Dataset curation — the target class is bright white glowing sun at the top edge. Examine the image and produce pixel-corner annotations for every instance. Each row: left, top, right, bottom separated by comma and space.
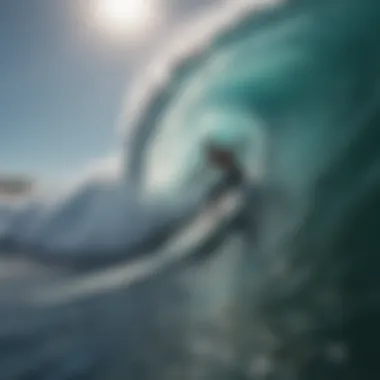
94, 0, 158, 37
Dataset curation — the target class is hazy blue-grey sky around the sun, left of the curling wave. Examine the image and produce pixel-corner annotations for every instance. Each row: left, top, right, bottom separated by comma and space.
0, 0, 218, 187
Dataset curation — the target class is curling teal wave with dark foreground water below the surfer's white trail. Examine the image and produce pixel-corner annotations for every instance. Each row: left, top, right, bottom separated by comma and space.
0, 0, 380, 380
